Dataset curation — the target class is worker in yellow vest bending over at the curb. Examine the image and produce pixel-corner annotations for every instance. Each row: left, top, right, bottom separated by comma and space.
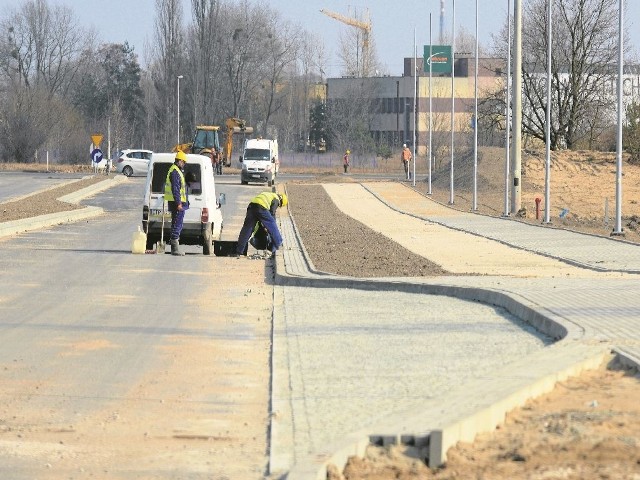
236, 192, 289, 255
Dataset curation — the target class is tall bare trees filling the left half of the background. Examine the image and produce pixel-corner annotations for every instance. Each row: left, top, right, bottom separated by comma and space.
0, 0, 325, 162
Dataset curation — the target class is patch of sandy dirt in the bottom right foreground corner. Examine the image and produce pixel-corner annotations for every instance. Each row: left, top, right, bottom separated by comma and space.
328, 367, 640, 480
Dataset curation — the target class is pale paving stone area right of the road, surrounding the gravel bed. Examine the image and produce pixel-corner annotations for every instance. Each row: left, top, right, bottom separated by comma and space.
272, 183, 640, 478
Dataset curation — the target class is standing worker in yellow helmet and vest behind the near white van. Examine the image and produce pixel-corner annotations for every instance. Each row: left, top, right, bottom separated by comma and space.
164, 150, 189, 255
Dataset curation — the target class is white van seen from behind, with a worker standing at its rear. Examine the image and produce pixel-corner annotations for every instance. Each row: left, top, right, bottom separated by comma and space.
142, 153, 225, 255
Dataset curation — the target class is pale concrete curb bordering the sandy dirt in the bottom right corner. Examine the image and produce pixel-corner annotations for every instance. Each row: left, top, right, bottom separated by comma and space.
286, 344, 613, 480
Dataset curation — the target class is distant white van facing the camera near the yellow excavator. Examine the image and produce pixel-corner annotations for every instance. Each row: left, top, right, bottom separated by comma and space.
240, 138, 280, 187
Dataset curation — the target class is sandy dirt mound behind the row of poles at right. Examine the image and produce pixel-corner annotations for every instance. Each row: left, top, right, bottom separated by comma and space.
424, 148, 640, 243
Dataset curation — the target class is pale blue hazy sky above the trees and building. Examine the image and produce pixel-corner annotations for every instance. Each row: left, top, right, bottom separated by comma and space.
0, 0, 640, 76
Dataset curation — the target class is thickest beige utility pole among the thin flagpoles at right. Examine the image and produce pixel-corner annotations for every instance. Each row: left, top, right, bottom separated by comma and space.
511, 0, 522, 215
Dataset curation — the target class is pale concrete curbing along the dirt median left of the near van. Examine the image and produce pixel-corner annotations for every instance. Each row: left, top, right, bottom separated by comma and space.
0, 176, 126, 238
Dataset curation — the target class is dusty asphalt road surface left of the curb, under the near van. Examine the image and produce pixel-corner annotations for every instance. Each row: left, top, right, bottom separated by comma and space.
0, 174, 272, 480
